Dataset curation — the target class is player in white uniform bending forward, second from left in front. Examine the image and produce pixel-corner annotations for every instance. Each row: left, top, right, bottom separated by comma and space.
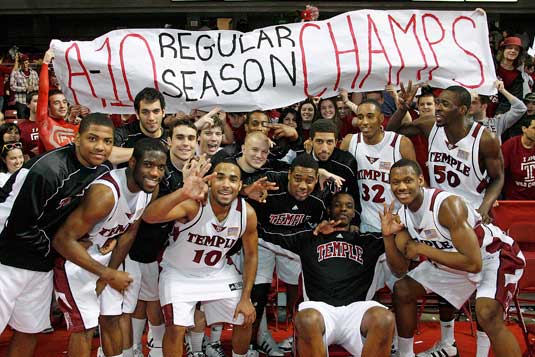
53, 139, 167, 356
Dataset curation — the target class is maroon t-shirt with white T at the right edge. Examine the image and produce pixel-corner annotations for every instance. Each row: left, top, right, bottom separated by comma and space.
502, 135, 535, 200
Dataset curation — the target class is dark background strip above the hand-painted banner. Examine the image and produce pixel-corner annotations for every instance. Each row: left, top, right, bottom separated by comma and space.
0, 0, 535, 52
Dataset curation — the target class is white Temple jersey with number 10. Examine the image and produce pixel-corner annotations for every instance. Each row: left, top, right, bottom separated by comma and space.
162, 198, 247, 278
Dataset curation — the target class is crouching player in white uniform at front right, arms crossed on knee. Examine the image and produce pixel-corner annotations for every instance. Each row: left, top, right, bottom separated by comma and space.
382, 159, 525, 357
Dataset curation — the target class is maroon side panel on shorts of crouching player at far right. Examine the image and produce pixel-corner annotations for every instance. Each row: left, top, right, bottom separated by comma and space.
486, 237, 526, 312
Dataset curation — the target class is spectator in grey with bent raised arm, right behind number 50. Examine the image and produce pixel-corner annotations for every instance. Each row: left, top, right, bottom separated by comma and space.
468, 80, 527, 143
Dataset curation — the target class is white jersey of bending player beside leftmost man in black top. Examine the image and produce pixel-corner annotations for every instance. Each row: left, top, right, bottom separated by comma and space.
89, 168, 152, 246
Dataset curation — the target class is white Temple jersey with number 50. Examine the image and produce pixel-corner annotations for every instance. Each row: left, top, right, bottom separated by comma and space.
427, 123, 488, 209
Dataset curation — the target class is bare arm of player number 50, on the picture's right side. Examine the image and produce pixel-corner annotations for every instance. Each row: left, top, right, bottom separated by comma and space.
478, 129, 505, 223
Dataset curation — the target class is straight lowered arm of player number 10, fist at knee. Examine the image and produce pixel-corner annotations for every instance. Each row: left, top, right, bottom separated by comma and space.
234, 204, 258, 326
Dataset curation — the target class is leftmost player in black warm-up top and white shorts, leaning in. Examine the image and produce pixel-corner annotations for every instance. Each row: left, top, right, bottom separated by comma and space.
0, 113, 115, 356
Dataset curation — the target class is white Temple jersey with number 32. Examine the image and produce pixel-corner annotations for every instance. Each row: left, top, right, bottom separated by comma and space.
349, 131, 402, 232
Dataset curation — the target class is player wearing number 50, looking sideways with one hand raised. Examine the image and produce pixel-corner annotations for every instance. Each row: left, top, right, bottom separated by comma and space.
387, 82, 504, 357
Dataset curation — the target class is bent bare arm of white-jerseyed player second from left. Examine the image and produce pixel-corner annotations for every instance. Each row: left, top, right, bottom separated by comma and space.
52, 184, 132, 290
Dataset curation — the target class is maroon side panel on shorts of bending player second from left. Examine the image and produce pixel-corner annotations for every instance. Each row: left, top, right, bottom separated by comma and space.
54, 257, 88, 332
